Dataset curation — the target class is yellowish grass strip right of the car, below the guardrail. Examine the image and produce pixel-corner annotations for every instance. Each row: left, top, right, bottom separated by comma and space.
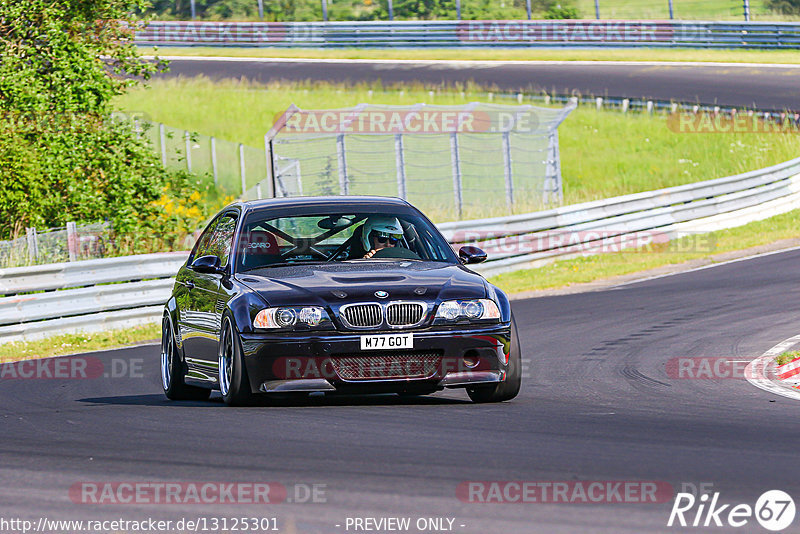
489, 210, 800, 294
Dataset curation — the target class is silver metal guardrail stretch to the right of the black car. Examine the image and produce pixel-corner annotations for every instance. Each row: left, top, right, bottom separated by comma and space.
446, 158, 800, 276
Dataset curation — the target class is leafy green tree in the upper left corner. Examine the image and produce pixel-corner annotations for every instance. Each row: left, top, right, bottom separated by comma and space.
0, 0, 169, 238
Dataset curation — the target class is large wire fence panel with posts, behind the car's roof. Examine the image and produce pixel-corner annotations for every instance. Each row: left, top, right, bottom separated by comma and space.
268, 102, 576, 220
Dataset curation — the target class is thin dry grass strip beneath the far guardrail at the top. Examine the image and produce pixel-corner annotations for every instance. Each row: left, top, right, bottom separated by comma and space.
140, 47, 797, 64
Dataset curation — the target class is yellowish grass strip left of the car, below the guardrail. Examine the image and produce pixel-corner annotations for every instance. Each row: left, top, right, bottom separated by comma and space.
0, 323, 161, 363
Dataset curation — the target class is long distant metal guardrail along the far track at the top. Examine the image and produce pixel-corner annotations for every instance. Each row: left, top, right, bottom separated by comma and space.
134, 20, 800, 48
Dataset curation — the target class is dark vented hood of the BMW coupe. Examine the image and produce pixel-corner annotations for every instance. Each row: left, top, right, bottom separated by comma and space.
237, 260, 486, 308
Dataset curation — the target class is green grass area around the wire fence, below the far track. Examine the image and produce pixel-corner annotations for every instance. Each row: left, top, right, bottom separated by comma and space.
116, 78, 800, 211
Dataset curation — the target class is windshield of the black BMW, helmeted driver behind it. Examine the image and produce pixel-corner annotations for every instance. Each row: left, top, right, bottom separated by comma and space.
237, 212, 457, 271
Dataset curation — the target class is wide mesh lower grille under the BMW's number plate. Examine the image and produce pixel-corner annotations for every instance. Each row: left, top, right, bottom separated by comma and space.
331, 351, 442, 380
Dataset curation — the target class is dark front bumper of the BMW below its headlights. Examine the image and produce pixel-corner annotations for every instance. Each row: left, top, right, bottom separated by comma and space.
241, 323, 511, 393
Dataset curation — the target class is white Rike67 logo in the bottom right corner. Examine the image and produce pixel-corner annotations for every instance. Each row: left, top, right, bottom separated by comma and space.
667, 490, 795, 532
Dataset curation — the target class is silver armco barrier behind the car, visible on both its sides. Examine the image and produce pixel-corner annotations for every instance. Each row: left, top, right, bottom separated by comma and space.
0, 158, 800, 341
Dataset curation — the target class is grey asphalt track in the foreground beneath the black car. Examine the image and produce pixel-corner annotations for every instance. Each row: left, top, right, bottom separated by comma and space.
0, 251, 800, 534
